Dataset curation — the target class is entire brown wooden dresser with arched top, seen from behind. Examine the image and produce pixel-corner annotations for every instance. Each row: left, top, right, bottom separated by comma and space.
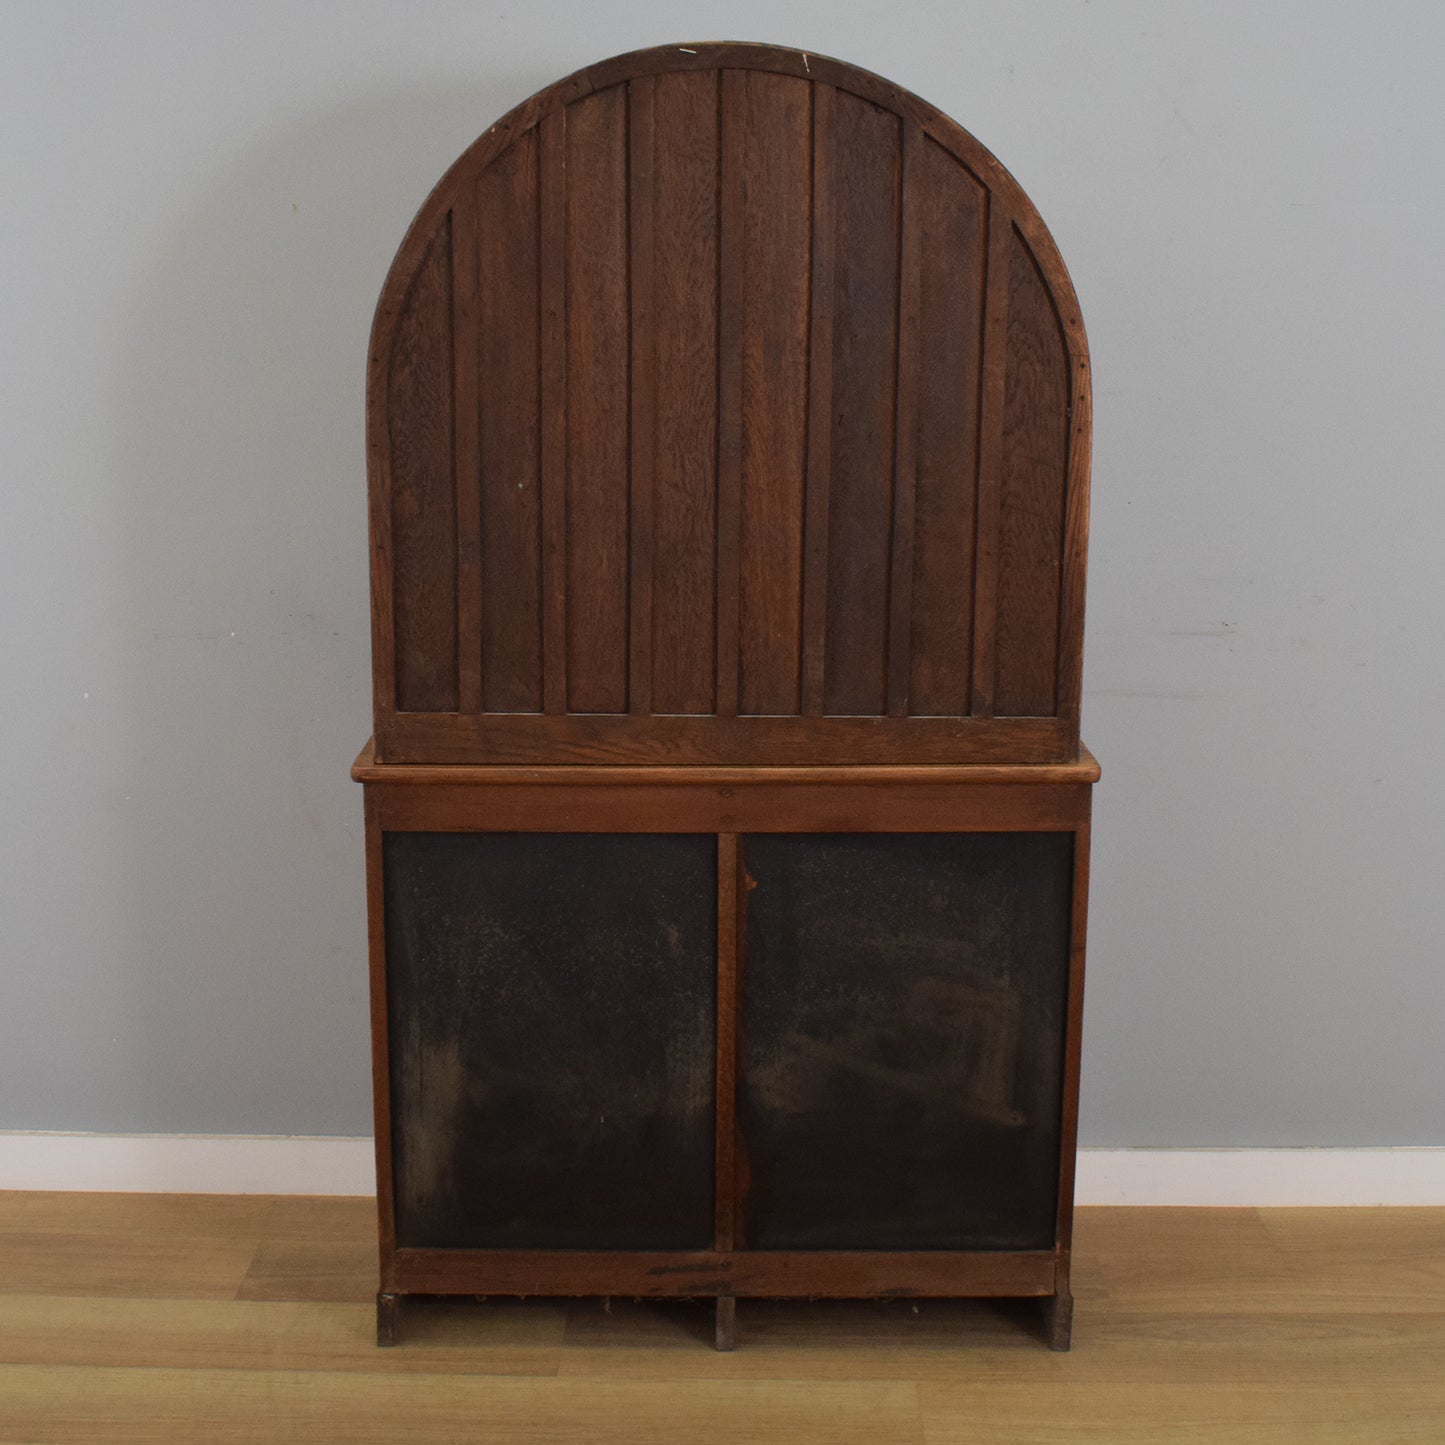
354, 45, 1098, 1348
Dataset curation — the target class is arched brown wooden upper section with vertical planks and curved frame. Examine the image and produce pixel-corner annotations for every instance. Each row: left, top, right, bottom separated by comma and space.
367, 43, 1090, 764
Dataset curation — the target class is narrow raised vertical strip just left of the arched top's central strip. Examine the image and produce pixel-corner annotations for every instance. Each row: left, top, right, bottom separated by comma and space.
627, 75, 657, 714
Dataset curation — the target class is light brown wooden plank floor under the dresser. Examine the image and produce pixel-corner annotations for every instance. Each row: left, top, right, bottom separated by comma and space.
0, 1194, 1445, 1445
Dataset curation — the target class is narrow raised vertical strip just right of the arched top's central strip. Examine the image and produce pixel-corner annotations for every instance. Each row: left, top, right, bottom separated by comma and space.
802, 81, 837, 717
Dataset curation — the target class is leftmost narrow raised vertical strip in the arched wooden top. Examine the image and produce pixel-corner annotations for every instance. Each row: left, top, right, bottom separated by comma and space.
451, 182, 481, 712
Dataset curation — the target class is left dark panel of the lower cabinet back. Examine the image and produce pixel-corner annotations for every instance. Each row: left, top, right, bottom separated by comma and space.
383, 832, 717, 1248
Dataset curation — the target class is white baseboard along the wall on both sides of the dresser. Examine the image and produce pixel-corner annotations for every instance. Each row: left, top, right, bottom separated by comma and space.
0, 1133, 1445, 1207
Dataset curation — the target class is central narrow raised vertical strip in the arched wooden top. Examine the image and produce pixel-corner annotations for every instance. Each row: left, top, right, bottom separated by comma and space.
717, 69, 747, 717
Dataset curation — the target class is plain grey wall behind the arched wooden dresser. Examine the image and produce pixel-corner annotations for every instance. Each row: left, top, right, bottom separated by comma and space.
0, 0, 1445, 1144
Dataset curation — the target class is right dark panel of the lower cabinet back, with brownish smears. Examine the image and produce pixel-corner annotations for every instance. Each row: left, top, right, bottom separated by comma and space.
738, 832, 1074, 1250
